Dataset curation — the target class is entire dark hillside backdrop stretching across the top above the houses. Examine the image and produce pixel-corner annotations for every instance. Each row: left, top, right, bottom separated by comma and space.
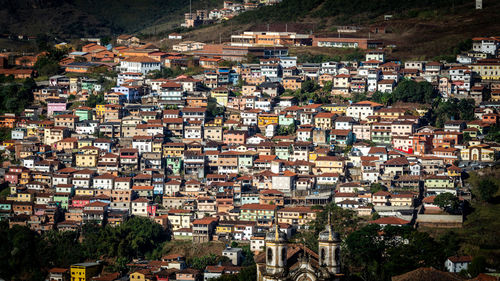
0, 0, 500, 59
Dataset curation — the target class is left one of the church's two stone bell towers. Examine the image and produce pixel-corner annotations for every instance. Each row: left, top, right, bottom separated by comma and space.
264, 212, 287, 281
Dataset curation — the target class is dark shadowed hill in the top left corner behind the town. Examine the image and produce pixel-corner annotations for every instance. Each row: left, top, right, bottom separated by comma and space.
0, 0, 223, 38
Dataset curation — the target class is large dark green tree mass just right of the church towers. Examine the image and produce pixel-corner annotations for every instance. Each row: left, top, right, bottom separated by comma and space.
343, 224, 446, 280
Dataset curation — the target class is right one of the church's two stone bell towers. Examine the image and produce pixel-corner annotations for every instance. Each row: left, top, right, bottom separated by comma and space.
318, 212, 340, 274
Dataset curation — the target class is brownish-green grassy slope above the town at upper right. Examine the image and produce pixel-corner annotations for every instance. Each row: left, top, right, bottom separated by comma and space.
179, 0, 500, 60
